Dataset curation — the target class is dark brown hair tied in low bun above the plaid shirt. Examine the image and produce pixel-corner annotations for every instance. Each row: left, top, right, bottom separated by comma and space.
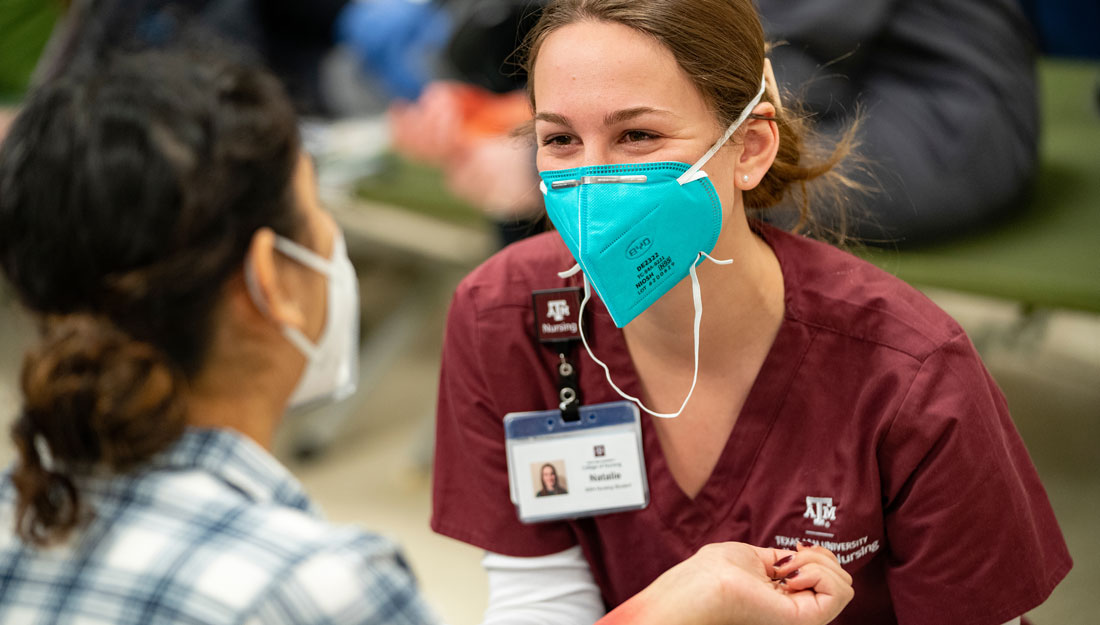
0, 41, 299, 545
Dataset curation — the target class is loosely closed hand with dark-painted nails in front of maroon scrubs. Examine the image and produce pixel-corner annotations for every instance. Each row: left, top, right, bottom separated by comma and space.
600, 542, 855, 625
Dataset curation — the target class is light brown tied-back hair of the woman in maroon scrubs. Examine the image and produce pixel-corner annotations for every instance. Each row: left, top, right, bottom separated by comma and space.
523, 0, 862, 242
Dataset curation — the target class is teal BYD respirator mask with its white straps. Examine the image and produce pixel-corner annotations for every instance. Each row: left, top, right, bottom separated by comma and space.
539, 79, 767, 417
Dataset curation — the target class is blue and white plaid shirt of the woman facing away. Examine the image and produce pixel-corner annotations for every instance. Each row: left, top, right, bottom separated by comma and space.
0, 429, 435, 625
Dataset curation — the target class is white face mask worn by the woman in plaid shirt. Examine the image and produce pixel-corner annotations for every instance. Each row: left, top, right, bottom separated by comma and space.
244, 230, 359, 409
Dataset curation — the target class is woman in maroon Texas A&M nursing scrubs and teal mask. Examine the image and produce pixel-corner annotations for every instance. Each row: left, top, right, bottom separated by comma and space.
432, 0, 1071, 625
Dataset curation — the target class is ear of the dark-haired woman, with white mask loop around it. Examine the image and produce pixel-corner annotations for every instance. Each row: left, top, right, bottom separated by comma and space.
244, 228, 306, 329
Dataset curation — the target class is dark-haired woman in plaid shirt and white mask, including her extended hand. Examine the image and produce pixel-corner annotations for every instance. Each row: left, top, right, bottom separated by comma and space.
0, 33, 851, 625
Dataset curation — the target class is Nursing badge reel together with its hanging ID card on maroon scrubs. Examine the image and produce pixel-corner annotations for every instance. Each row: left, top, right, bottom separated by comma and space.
504, 288, 649, 523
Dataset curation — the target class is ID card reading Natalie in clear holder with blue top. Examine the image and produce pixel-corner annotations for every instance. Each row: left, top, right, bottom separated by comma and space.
504, 402, 649, 523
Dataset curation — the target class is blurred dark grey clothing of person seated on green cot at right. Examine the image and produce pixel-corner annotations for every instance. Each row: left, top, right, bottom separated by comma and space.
758, 0, 1038, 244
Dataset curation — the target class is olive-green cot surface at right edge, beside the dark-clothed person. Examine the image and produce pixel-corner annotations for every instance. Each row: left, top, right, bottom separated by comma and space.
861, 61, 1100, 313
